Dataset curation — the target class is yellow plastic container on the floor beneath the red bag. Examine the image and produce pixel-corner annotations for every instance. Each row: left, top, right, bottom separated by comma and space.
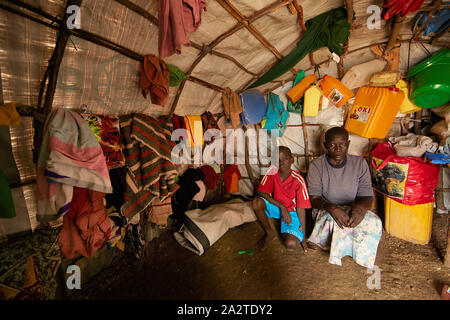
384, 197, 434, 244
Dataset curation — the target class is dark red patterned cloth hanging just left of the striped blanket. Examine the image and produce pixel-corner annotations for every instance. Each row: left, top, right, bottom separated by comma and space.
81, 113, 125, 169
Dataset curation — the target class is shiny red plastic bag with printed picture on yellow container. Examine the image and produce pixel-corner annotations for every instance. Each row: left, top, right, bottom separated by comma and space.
371, 142, 440, 205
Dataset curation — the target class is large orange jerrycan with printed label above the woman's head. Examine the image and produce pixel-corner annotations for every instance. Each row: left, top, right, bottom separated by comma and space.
345, 86, 404, 139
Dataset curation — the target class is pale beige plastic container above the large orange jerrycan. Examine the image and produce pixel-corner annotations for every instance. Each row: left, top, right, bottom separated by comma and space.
341, 59, 386, 89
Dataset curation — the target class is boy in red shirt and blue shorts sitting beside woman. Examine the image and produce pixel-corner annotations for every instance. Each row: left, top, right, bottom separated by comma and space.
253, 146, 311, 252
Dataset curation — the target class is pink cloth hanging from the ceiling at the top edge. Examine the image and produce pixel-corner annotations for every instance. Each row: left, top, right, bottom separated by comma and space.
158, 0, 206, 59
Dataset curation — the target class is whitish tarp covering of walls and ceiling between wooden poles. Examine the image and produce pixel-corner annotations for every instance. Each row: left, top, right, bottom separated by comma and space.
0, 0, 448, 235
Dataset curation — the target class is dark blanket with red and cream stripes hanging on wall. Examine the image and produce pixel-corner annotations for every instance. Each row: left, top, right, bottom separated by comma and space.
120, 114, 178, 219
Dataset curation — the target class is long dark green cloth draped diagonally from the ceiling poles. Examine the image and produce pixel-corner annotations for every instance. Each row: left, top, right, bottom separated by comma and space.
248, 8, 350, 89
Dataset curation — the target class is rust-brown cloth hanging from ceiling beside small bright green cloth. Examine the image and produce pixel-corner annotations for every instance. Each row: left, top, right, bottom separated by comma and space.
141, 54, 170, 106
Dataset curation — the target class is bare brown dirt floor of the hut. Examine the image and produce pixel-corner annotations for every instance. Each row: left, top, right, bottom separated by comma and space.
70, 210, 450, 300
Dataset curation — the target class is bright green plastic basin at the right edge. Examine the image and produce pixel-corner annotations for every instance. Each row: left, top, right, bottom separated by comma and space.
408, 48, 450, 108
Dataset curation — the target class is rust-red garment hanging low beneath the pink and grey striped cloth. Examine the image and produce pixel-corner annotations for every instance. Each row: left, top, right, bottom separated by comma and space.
59, 187, 111, 259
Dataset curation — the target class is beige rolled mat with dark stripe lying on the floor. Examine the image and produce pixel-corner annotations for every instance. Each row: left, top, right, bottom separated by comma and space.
173, 199, 256, 256
